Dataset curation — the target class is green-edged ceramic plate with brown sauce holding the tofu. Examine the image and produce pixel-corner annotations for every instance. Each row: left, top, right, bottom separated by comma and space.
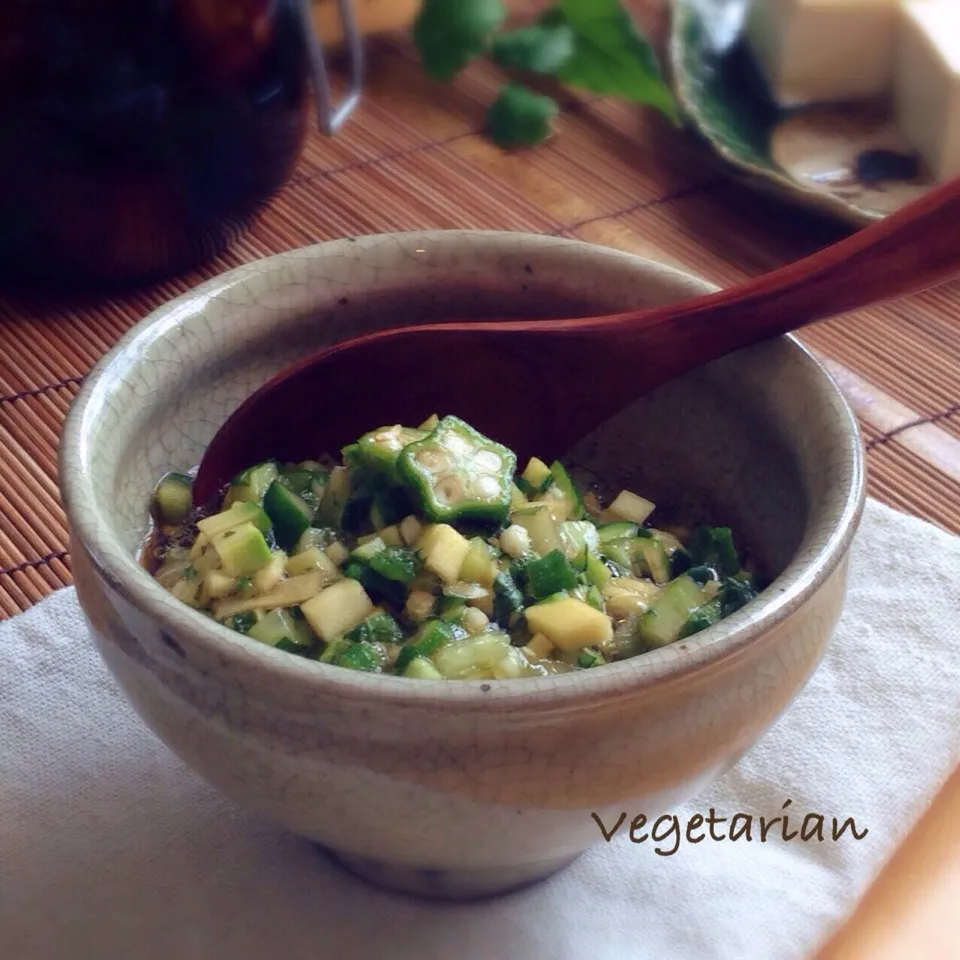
669, 0, 933, 226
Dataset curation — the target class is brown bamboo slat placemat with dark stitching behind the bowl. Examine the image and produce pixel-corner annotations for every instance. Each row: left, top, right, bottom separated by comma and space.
0, 15, 960, 619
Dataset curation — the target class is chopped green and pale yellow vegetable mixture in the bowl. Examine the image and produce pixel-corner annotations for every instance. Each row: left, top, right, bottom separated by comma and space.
148, 416, 759, 680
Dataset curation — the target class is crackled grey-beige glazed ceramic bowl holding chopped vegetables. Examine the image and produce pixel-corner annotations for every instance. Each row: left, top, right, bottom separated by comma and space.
61, 231, 864, 899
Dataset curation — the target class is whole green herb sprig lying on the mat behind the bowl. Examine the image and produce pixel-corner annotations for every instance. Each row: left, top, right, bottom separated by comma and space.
413, 0, 679, 149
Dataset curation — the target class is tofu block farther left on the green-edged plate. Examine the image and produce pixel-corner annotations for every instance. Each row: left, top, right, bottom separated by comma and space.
745, 0, 900, 106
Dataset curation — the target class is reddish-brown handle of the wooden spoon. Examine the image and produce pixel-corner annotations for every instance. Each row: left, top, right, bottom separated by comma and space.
608, 172, 960, 366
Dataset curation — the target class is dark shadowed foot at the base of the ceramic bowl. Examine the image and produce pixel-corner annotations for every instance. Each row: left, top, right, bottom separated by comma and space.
318, 844, 580, 901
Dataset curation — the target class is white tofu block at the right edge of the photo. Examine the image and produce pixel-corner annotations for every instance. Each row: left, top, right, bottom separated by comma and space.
894, 0, 960, 180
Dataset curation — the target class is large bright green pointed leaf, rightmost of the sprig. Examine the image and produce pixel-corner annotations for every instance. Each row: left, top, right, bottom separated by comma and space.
557, 0, 678, 123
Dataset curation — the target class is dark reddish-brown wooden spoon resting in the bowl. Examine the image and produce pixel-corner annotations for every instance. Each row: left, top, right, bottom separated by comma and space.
194, 179, 960, 502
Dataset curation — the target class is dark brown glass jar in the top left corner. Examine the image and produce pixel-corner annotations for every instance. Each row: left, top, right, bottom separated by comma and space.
0, 0, 310, 285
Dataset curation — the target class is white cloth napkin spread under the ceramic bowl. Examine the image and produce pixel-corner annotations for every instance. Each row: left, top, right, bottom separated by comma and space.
0, 501, 960, 960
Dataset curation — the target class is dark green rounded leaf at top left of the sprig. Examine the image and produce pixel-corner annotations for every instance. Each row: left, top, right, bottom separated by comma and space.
413, 0, 506, 81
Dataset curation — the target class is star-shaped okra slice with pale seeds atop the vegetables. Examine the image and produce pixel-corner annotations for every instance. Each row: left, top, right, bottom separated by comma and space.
398, 417, 517, 525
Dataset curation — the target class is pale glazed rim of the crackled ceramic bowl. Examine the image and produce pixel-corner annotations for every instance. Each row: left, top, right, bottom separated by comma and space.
58, 229, 866, 711
